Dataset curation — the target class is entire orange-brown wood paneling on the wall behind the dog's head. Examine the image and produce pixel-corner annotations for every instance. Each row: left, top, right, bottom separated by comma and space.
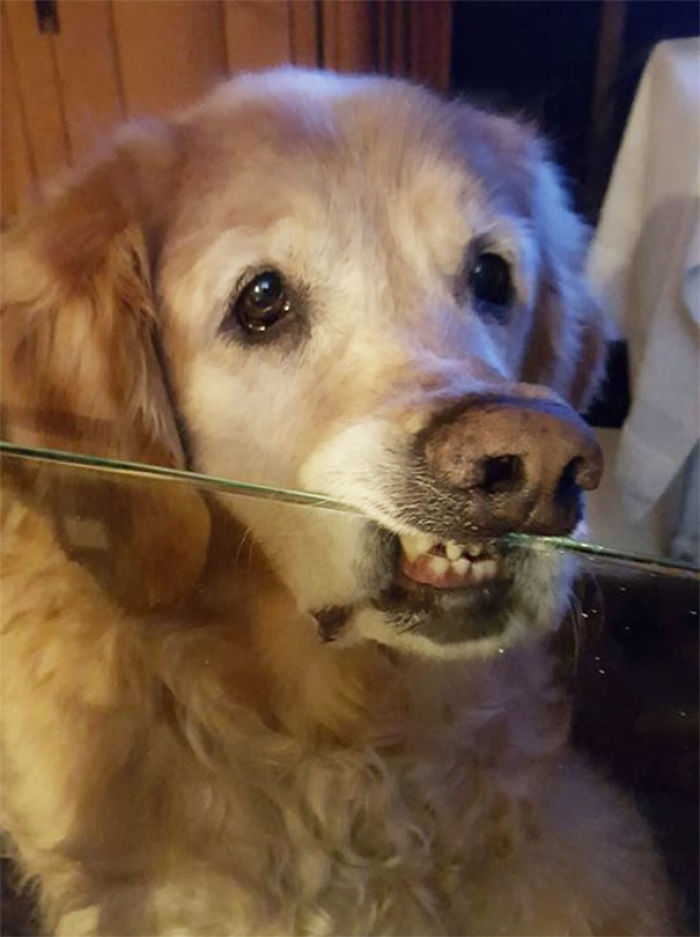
0, 0, 450, 218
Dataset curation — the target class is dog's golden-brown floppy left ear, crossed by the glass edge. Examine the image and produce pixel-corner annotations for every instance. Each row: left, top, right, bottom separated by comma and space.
1, 126, 209, 609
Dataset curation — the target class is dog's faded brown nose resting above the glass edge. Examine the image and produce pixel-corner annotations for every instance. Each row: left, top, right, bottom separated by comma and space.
420, 395, 603, 535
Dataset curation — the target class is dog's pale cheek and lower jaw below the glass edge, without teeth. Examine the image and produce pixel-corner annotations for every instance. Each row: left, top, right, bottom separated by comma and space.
216, 482, 570, 659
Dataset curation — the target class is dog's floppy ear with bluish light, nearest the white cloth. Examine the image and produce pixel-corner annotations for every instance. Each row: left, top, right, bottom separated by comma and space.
522, 152, 609, 412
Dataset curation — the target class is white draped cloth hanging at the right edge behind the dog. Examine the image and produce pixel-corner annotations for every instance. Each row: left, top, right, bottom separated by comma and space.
588, 38, 700, 540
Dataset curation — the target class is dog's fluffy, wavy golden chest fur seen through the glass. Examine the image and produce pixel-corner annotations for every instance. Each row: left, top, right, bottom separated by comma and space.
3, 494, 584, 934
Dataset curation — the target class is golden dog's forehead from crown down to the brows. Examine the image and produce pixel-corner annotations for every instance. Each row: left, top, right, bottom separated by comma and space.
161, 70, 540, 324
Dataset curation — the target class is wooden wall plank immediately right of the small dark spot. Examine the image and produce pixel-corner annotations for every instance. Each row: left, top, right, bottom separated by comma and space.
51, 0, 125, 155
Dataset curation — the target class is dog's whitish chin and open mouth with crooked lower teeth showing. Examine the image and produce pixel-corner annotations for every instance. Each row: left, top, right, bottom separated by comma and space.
334, 530, 571, 658
